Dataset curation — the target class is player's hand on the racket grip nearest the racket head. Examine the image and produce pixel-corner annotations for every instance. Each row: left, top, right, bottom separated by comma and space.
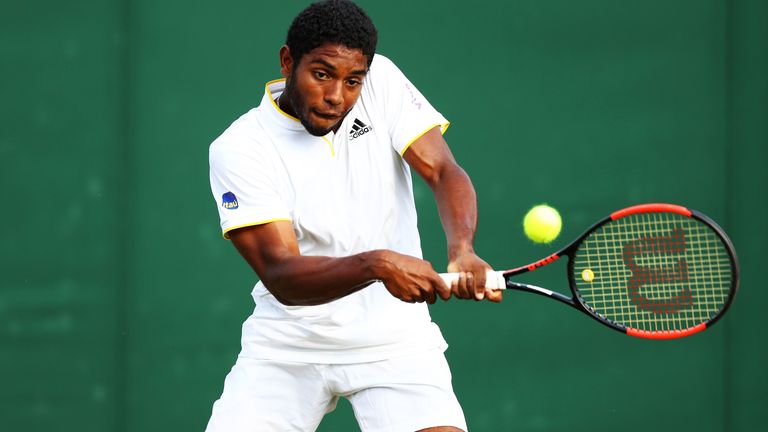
448, 252, 503, 303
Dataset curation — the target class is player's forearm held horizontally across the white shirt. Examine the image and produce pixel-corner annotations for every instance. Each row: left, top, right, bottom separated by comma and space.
262, 251, 388, 306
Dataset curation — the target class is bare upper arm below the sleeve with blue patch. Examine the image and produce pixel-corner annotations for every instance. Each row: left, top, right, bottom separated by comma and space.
229, 221, 300, 280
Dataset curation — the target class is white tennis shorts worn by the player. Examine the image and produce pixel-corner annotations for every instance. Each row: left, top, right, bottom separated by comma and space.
206, 350, 467, 432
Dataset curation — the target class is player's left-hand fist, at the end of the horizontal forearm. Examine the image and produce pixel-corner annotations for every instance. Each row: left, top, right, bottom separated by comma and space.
379, 251, 451, 304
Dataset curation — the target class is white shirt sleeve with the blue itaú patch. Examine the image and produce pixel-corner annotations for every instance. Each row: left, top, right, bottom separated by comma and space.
209, 138, 291, 239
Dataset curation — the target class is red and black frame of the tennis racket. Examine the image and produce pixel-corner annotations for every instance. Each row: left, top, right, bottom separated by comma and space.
502, 204, 739, 339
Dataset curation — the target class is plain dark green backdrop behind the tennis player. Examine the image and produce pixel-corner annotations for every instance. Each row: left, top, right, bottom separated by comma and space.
0, 0, 768, 432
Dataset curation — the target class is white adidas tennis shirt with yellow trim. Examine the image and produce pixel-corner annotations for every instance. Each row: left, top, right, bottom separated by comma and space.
210, 55, 448, 364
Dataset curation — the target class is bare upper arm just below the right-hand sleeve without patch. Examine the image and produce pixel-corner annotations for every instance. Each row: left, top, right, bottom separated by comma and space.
403, 126, 456, 187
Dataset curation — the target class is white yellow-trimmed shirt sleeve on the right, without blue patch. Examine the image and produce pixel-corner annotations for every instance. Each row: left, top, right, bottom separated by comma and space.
369, 54, 450, 156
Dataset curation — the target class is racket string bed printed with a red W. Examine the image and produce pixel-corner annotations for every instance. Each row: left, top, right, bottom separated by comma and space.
573, 213, 733, 331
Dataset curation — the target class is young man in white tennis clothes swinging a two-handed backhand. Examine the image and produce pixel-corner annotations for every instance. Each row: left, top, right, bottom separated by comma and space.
207, 0, 501, 432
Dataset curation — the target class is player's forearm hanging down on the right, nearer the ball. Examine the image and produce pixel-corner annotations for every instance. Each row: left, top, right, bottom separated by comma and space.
430, 164, 477, 260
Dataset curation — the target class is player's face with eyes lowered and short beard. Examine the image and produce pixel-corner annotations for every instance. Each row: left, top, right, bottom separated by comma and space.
280, 44, 368, 136
